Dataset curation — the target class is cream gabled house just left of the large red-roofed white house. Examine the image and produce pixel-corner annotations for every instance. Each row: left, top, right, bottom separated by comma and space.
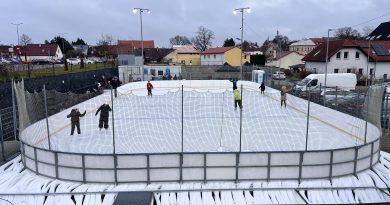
265, 51, 304, 69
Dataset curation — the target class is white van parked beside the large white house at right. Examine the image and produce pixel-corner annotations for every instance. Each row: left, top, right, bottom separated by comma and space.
294, 73, 357, 91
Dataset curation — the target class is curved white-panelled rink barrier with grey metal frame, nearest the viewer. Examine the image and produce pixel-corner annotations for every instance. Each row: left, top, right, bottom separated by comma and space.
21, 139, 380, 184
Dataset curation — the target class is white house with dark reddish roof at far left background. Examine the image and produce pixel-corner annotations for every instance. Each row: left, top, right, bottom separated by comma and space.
20, 44, 63, 62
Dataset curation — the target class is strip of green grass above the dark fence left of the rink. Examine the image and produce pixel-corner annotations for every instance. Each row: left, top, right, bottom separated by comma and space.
0, 63, 115, 81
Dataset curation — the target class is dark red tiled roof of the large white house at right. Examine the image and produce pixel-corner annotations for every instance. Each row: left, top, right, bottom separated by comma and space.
302, 39, 390, 62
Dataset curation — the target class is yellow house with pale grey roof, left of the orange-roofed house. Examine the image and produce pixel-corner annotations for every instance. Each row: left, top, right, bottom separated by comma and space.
166, 45, 200, 65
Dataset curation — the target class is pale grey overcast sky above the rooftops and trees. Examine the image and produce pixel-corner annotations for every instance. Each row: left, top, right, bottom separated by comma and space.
0, 0, 390, 47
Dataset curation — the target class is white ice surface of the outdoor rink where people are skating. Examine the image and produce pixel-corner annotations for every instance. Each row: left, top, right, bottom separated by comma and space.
21, 80, 380, 154
